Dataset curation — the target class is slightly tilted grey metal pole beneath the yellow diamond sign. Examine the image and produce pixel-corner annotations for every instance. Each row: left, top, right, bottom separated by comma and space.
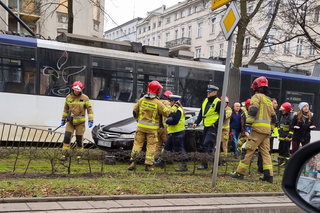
212, 33, 233, 188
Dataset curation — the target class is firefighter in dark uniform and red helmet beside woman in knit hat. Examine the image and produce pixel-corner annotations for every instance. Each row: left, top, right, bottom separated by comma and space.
278, 102, 293, 167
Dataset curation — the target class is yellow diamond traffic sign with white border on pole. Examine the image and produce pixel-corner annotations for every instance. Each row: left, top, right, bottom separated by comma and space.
220, 2, 240, 40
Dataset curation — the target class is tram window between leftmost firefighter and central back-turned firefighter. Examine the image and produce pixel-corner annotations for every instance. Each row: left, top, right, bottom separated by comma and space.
91, 58, 134, 102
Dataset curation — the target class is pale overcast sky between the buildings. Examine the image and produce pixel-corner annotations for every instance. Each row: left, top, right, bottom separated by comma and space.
104, 0, 184, 31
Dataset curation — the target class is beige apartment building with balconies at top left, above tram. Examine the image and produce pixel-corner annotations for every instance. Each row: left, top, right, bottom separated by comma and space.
0, 0, 105, 39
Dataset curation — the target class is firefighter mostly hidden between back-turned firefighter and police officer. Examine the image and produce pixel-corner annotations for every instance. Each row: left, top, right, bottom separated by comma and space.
156, 90, 173, 153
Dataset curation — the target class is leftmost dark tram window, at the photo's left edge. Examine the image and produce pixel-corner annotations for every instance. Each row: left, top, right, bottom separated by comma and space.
0, 58, 36, 94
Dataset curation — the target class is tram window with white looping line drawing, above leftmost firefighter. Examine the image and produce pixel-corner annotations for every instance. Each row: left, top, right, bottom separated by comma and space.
39, 49, 88, 97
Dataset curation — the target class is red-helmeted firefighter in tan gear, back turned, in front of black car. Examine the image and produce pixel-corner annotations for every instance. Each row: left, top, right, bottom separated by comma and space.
128, 81, 180, 171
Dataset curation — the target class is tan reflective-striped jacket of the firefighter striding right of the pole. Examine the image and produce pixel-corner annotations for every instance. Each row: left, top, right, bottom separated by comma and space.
247, 93, 275, 135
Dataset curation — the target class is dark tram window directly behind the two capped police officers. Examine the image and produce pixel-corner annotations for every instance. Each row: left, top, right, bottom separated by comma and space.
178, 67, 214, 107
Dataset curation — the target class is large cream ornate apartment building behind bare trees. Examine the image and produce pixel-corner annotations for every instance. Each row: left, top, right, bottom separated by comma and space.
137, 0, 320, 74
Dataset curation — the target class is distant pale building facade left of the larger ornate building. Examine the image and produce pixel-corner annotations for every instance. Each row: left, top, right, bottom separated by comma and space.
104, 17, 142, 41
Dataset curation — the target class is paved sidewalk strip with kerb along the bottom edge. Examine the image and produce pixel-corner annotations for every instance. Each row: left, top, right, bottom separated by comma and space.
0, 193, 305, 213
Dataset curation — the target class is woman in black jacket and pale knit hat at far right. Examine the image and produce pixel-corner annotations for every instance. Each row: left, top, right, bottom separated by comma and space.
291, 102, 316, 155
